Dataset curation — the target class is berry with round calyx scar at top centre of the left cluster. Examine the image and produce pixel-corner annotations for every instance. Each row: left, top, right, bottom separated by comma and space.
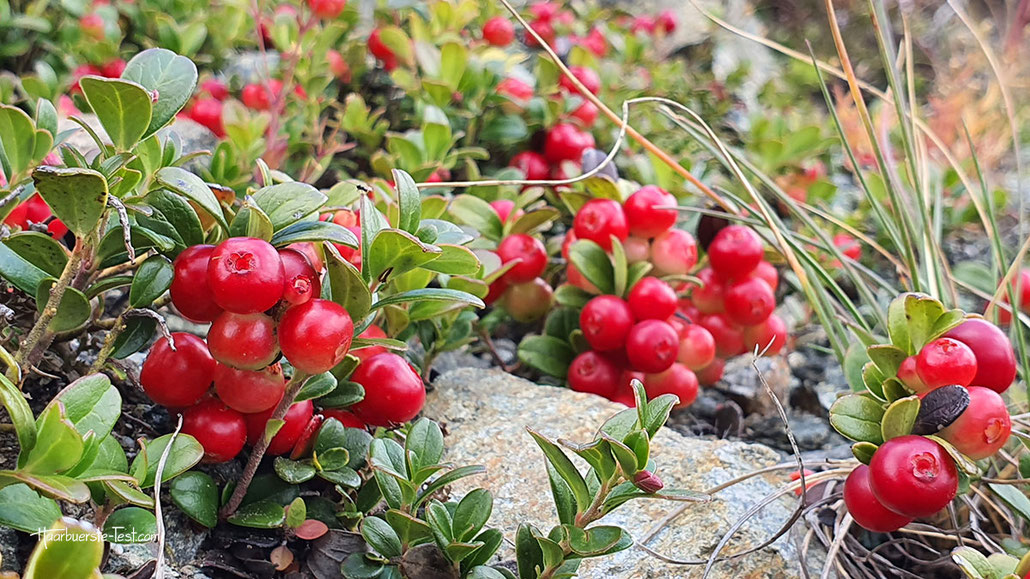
207, 237, 285, 313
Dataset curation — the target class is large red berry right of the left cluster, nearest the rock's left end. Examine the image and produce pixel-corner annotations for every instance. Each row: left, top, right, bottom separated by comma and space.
350, 352, 425, 427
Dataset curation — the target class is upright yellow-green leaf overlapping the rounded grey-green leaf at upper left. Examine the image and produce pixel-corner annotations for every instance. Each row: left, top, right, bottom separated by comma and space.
78, 75, 153, 150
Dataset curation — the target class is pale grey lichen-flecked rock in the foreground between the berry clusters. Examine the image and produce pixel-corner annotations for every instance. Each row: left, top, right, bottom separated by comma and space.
425, 369, 798, 579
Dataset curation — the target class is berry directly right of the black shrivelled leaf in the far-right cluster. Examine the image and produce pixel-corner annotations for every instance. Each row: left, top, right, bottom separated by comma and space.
938, 386, 1012, 461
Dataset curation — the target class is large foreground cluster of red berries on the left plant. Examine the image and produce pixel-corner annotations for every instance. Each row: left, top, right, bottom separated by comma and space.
140, 237, 425, 462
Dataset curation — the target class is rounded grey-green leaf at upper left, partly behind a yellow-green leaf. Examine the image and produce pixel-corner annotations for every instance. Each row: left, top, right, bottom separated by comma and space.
122, 48, 197, 137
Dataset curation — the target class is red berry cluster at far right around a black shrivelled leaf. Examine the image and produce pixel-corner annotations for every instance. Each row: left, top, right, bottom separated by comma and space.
844, 318, 1016, 533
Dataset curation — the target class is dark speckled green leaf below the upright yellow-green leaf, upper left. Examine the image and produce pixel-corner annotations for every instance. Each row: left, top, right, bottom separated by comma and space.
32, 165, 107, 237
